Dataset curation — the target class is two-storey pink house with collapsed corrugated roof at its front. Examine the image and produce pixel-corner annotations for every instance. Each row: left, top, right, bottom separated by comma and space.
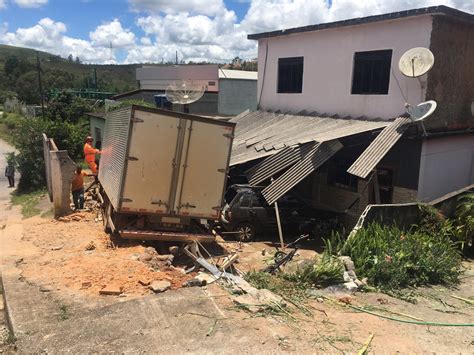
231, 6, 474, 225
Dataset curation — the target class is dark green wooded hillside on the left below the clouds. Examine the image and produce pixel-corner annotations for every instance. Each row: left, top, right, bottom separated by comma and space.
0, 45, 138, 104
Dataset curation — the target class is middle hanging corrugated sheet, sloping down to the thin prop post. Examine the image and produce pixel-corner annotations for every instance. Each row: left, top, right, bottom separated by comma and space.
262, 140, 343, 205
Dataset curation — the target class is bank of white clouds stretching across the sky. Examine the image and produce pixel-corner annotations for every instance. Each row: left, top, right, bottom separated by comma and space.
0, 0, 474, 63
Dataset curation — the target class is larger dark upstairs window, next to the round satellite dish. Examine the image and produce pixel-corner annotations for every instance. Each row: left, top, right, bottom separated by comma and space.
351, 49, 392, 95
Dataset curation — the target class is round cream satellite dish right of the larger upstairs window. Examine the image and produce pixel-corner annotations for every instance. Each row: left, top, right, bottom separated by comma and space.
398, 47, 434, 78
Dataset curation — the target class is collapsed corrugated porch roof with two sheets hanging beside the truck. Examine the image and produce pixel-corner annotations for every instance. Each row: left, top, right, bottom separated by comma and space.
230, 111, 392, 204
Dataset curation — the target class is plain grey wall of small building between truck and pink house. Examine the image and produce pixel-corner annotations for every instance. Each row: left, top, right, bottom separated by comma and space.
217, 79, 257, 115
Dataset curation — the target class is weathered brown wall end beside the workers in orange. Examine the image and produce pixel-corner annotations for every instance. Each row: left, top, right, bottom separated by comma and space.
50, 150, 76, 217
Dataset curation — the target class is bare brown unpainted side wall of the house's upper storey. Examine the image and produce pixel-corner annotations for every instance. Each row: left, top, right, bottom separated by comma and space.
426, 16, 474, 131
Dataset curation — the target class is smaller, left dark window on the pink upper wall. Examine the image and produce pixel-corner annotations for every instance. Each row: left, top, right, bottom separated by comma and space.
277, 57, 304, 94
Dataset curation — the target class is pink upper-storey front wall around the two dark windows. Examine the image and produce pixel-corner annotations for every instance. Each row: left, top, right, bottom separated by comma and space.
257, 16, 432, 119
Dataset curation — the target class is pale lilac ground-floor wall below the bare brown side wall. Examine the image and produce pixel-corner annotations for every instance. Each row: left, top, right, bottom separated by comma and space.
418, 134, 474, 201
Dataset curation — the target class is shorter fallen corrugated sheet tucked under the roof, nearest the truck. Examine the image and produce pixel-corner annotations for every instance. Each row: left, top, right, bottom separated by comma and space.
247, 143, 315, 186
